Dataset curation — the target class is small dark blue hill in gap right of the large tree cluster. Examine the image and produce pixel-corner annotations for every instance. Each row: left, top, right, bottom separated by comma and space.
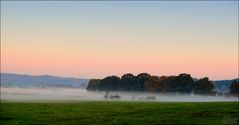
213, 78, 239, 93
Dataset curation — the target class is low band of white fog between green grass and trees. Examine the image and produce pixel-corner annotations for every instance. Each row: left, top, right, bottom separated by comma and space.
1, 87, 239, 102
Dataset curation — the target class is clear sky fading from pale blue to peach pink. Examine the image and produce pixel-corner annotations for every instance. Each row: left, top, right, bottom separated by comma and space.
1, 1, 239, 80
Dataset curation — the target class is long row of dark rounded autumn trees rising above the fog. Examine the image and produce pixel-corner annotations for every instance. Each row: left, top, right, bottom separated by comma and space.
87, 73, 215, 94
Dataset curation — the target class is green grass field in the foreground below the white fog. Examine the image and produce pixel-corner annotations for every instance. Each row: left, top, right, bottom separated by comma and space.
0, 101, 239, 125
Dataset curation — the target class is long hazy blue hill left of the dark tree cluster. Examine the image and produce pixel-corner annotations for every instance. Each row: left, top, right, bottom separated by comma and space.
1, 73, 89, 88
